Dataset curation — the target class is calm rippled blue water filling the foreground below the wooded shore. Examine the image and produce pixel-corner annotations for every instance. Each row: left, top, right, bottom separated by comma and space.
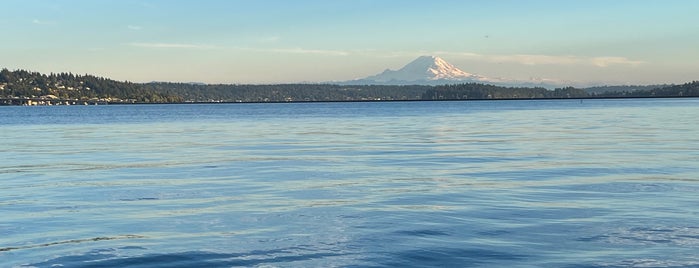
0, 99, 699, 267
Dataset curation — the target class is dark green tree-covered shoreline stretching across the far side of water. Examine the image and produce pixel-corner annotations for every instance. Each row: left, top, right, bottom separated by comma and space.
0, 69, 699, 105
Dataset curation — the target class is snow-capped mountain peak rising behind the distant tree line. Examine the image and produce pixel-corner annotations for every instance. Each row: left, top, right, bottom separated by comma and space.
346, 56, 491, 85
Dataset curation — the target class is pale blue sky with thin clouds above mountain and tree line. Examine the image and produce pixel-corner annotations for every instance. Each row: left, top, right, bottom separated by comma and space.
0, 0, 699, 85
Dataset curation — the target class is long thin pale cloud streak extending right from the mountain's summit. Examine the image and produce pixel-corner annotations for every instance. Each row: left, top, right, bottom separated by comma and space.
436, 52, 645, 67
